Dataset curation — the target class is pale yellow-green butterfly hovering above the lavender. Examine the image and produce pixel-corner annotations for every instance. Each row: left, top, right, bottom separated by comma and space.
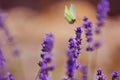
64, 4, 76, 24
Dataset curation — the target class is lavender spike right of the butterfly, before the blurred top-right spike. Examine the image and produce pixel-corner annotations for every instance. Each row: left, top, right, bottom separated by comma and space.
83, 17, 94, 51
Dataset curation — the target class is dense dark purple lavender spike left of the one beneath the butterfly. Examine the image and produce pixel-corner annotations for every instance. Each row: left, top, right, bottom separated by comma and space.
67, 38, 77, 80
